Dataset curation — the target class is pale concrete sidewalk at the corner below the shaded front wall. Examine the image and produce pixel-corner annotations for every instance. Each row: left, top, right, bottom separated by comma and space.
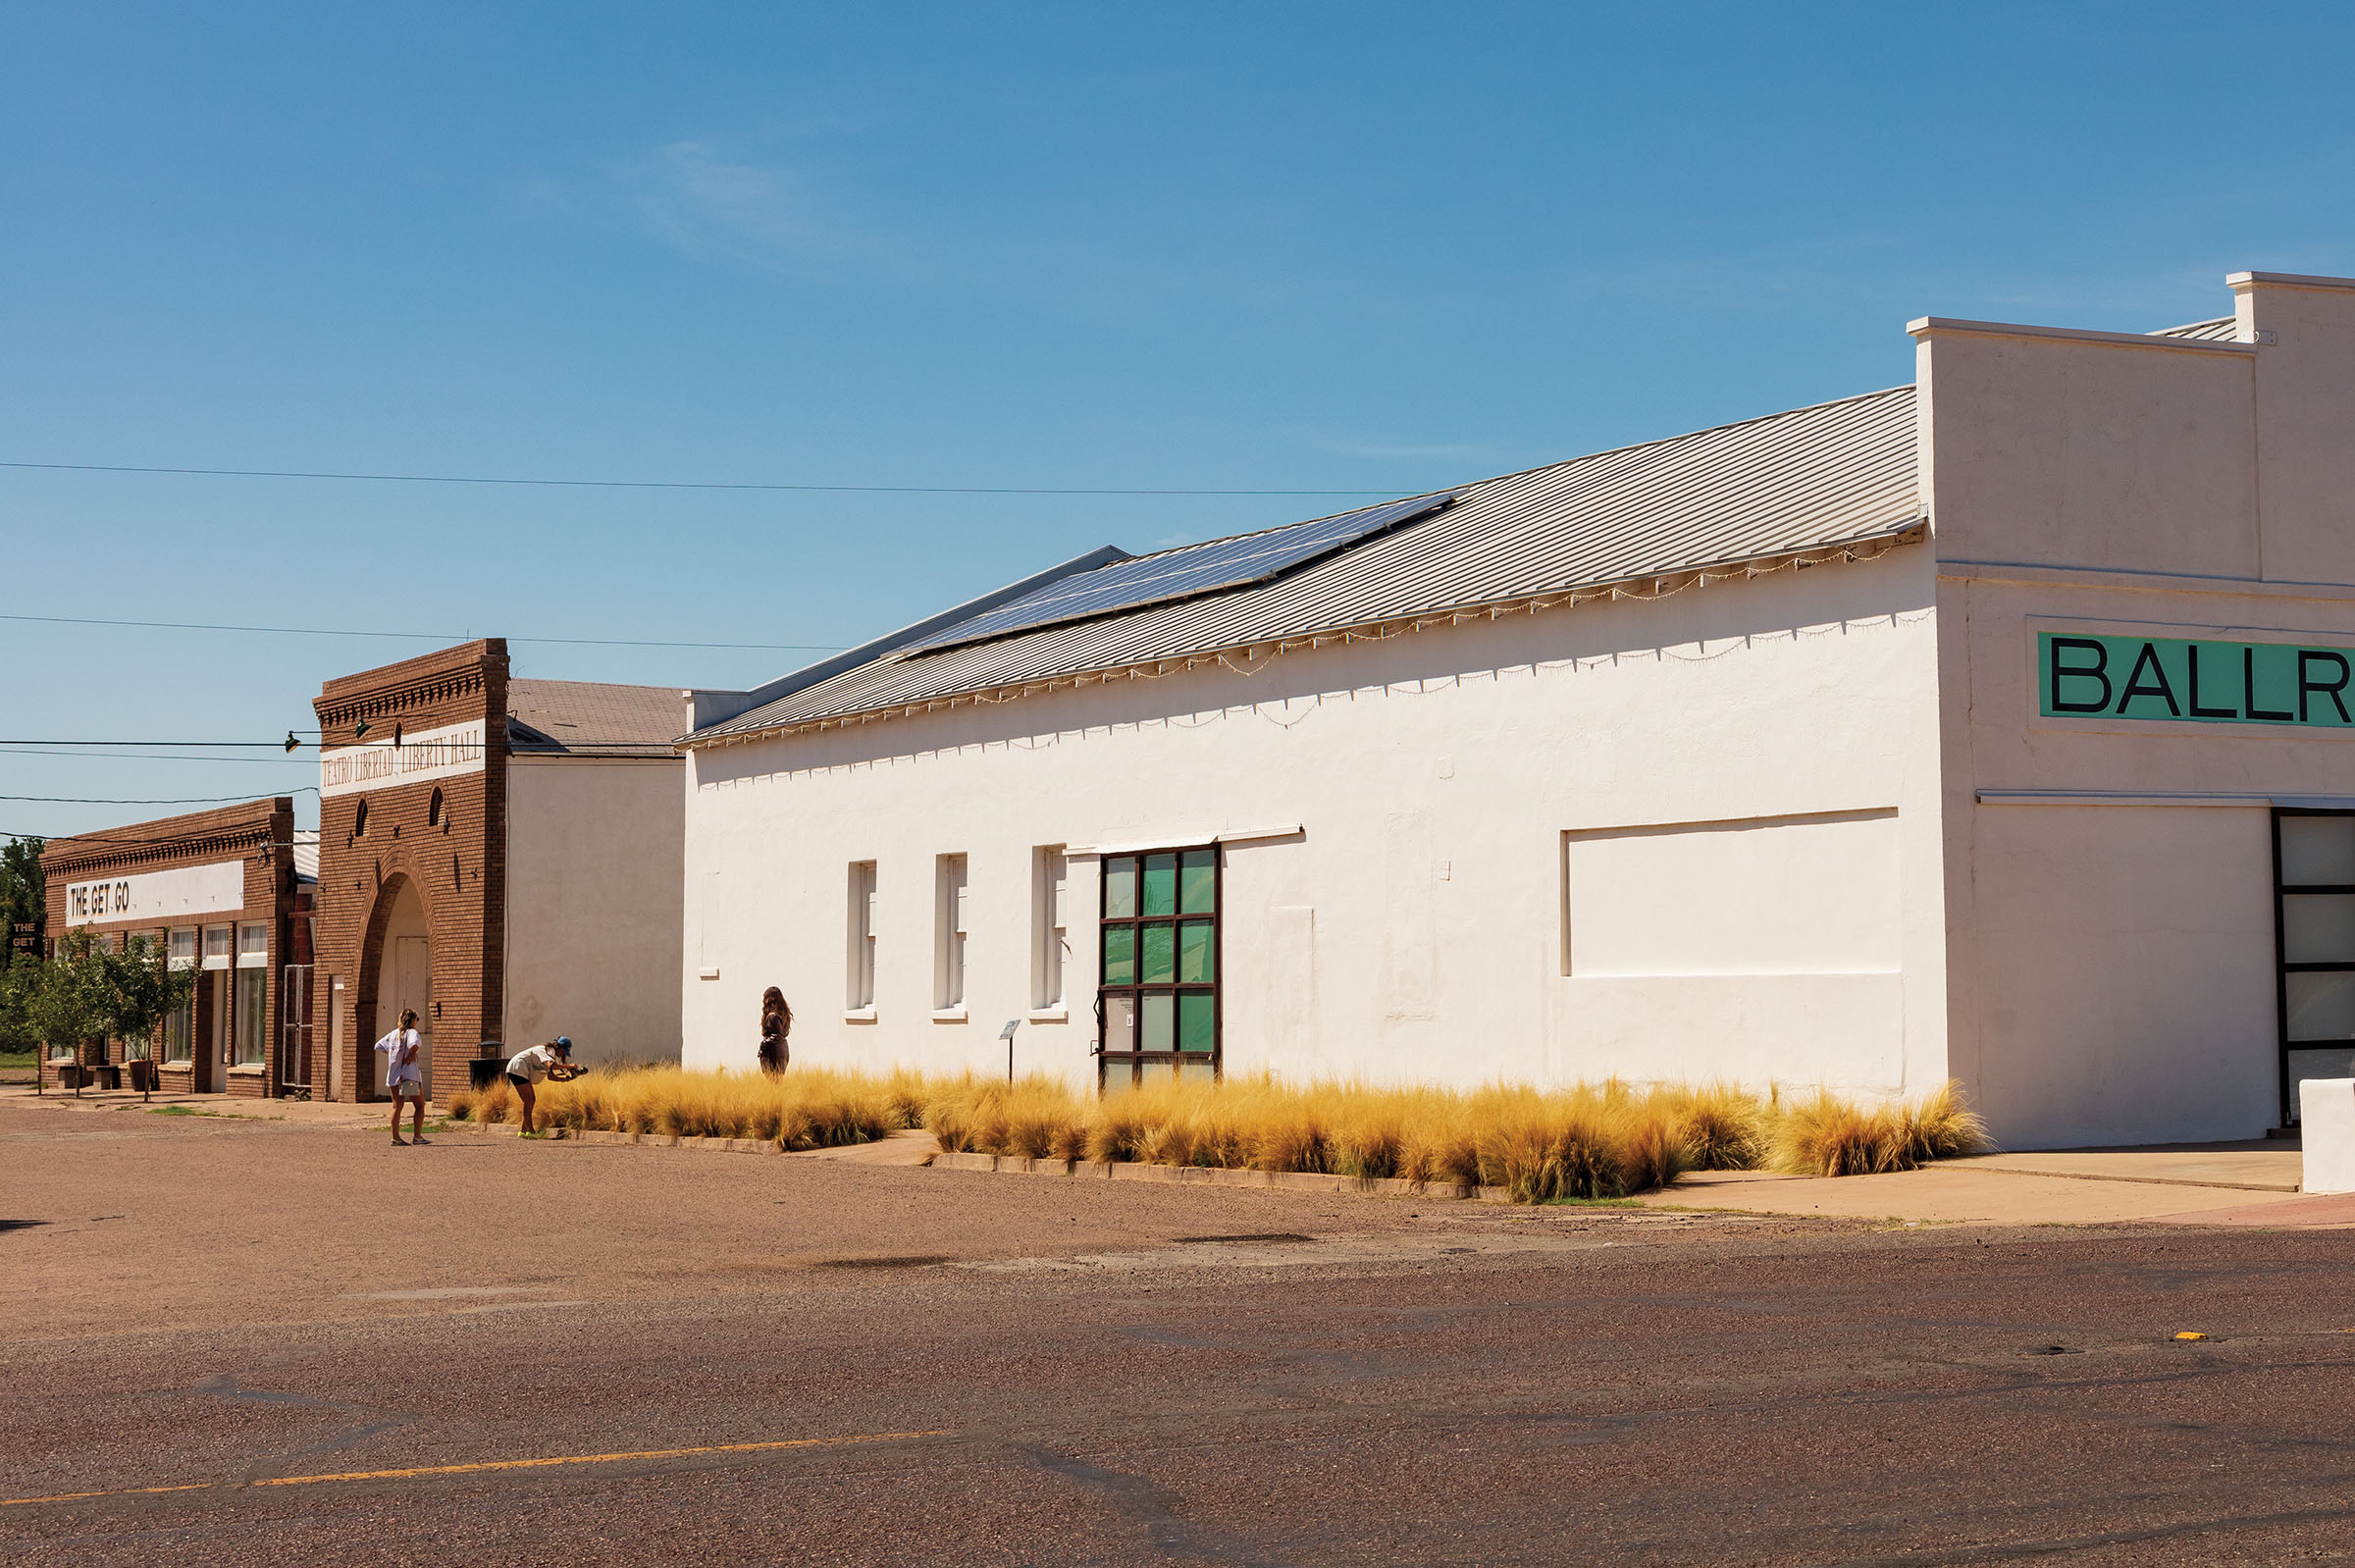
1642, 1139, 2355, 1228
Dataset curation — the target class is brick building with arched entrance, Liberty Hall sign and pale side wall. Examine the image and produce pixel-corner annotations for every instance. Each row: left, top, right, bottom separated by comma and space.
313, 638, 685, 1100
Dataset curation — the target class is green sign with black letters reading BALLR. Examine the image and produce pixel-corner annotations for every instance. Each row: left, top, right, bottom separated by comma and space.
2037, 631, 2355, 730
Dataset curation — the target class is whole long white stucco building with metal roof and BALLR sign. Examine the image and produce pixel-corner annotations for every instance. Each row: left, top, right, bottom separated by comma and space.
683, 273, 2355, 1147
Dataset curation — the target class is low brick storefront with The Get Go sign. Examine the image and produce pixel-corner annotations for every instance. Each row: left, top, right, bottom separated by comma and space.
40, 796, 311, 1097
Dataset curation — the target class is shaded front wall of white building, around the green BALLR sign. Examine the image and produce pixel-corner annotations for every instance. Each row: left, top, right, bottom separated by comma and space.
1919, 274, 2355, 1147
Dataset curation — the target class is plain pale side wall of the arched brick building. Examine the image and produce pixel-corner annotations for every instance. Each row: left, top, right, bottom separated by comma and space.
504, 756, 683, 1062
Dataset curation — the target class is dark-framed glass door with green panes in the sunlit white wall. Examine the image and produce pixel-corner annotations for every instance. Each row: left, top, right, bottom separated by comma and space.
1095, 845, 1220, 1095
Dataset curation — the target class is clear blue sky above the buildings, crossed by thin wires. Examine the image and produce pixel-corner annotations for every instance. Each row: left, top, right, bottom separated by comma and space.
0, 0, 2355, 833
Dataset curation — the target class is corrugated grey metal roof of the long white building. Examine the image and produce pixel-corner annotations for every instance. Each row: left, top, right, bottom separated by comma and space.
683, 387, 1921, 744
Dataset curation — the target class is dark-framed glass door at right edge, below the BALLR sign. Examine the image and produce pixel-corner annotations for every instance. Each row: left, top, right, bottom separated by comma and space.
2273, 808, 2355, 1125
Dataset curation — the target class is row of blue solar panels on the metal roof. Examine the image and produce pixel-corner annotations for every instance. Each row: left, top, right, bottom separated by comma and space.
905, 492, 1455, 654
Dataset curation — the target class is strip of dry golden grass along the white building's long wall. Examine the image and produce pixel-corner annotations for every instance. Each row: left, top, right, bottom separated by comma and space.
449, 1067, 1988, 1203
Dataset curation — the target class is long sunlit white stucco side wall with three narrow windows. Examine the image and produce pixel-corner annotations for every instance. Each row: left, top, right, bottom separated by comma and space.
681, 549, 1945, 1090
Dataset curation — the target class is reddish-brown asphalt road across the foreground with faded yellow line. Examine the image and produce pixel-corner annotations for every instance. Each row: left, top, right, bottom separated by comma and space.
0, 1109, 2355, 1563
